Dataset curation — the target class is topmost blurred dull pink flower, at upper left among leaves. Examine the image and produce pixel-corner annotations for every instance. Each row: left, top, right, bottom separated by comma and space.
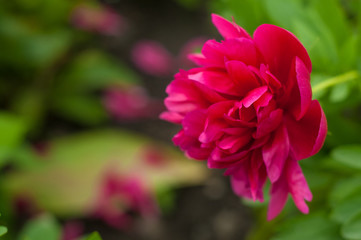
71, 4, 126, 35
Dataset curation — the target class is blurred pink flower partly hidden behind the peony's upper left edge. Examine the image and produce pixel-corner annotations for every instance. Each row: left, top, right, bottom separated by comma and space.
178, 37, 207, 68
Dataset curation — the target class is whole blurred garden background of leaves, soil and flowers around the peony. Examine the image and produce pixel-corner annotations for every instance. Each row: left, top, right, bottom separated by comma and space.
0, 0, 361, 240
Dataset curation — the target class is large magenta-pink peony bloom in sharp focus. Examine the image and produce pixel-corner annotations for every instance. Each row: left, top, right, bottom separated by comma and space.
161, 15, 327, 220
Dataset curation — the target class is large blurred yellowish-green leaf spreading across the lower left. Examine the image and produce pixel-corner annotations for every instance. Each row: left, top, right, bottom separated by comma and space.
3, 129, 206, 216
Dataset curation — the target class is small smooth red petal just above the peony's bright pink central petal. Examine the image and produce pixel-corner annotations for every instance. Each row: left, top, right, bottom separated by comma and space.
226, 60, 260, 96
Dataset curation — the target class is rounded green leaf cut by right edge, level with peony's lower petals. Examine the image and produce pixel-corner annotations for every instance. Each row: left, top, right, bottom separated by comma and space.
331, 145, 361, 170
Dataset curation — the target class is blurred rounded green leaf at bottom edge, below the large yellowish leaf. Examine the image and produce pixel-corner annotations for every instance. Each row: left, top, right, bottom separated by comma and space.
18, 215, 61, 240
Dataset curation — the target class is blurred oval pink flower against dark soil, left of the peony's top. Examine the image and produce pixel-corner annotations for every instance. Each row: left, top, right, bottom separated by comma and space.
132, 40, 174, 77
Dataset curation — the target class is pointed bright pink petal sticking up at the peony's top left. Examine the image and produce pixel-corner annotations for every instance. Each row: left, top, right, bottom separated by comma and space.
212, 13, 251, 39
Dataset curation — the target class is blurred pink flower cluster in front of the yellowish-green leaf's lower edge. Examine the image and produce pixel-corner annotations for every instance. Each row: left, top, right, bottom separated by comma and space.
94, 172, 158, 229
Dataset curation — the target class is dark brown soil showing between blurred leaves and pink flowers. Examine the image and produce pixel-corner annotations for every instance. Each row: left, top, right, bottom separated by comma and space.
85, 0, 252, 240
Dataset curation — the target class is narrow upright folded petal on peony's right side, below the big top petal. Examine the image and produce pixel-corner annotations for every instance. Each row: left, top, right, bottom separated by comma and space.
287, 57, 312, 120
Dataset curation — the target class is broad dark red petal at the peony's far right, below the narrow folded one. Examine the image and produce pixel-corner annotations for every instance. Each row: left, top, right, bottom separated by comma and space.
285, 100, 327, 160
